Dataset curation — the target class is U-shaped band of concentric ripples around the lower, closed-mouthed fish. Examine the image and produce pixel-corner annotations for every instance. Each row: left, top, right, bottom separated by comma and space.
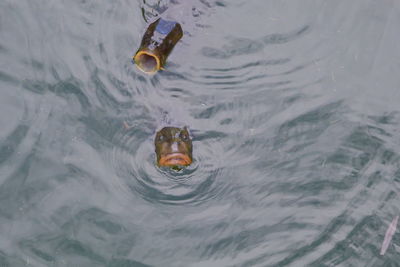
111, 122, 225, 205
